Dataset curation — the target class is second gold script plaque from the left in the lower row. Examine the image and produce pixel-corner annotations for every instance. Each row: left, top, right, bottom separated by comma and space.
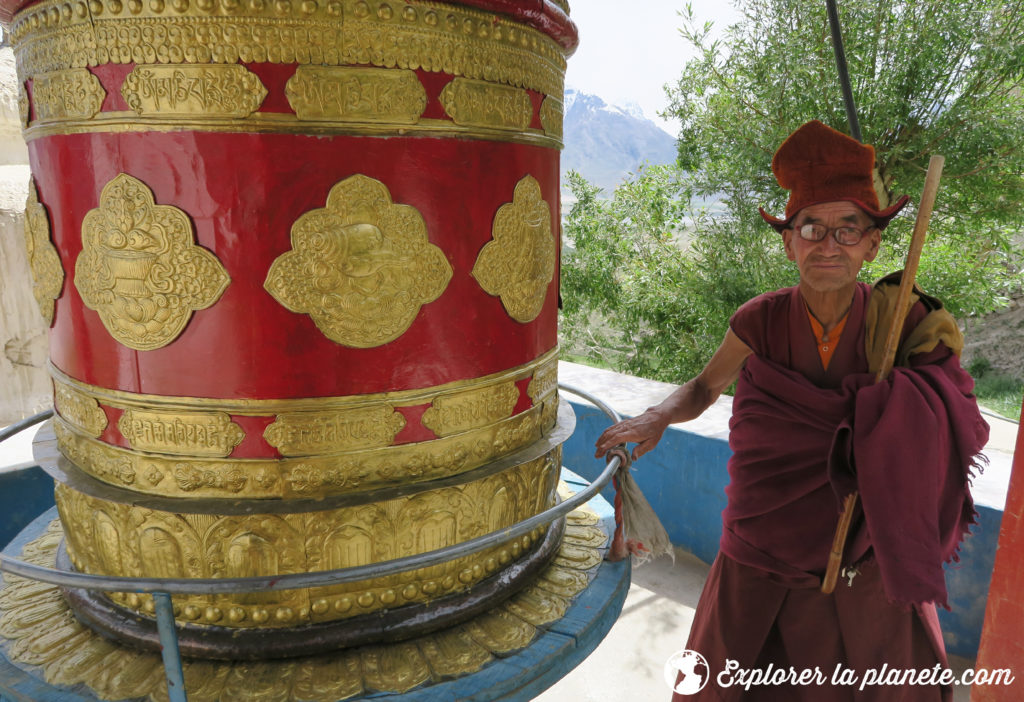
118, 409, 246, 457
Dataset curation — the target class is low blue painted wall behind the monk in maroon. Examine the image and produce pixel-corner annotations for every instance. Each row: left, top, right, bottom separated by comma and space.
562, 402, 1002, 658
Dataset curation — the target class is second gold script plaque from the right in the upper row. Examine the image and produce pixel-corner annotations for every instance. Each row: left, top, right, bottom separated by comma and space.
440, 78, 534, 131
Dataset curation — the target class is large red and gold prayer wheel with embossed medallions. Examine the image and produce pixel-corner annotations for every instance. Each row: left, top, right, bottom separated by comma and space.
8, 0, 575, 657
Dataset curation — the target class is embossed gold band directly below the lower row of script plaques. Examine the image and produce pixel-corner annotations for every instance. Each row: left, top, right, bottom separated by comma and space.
53, 390, 558, 498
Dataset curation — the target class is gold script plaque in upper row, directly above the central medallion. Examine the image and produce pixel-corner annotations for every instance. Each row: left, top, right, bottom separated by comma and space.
285, 65, 427, 125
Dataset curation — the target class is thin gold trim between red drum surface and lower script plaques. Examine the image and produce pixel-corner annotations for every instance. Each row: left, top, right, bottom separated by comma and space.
49, 346, 558, 416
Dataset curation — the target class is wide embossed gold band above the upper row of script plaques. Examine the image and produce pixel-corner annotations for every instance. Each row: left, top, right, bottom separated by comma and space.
11, 0, 565, 94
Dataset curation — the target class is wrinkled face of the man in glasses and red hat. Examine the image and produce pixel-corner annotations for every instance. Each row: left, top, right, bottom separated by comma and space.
782, 202, 882, 293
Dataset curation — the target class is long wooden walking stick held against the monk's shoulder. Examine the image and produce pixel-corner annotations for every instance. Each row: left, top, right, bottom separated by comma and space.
821, 156, 945, 595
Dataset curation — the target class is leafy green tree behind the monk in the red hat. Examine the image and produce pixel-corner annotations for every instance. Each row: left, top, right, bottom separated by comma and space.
563, 0, 1024, 382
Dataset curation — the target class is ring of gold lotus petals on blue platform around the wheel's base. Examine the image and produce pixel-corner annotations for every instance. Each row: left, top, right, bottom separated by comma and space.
0, 506, 603, 702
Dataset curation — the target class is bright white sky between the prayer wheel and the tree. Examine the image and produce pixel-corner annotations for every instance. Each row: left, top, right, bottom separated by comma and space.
565, 0, 736, 136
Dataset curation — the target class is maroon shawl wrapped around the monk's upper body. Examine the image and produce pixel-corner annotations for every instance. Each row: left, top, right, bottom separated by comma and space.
721, 286, 987, 606
